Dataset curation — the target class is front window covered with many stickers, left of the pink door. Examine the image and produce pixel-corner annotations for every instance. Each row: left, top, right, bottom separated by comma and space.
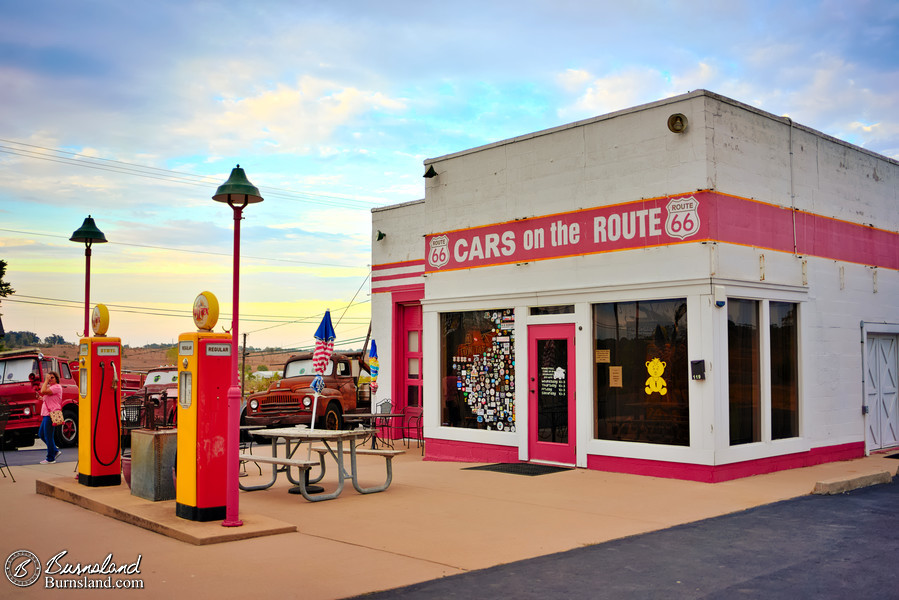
440, 308, 515, 431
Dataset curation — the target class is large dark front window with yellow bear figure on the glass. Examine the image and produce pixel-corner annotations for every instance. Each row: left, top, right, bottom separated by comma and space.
593, 298, 690, 446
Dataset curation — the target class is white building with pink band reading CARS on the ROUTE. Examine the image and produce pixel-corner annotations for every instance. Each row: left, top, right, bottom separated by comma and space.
372, 90, 899, 482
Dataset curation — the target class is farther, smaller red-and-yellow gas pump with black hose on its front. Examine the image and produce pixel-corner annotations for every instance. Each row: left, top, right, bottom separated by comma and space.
78, 304, 122, 487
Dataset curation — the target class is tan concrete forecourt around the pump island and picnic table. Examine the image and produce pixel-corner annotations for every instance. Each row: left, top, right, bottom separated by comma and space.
0, 449, 899, 600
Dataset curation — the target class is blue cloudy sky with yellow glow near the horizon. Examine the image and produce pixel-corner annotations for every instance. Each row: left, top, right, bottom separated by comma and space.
0, 0, 899, 347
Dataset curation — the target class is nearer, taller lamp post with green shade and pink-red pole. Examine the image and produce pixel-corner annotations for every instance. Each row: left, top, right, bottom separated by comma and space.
212, 165, 262, 527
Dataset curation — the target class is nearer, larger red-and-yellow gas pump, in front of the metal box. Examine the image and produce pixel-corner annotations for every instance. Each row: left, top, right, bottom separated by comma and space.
175, 292, 231, 521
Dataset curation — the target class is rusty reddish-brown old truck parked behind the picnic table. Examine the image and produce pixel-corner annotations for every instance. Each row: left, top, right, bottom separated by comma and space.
240, 352, 371, 429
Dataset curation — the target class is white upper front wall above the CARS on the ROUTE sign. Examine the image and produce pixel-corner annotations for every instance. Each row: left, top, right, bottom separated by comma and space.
425, 96, 707, 233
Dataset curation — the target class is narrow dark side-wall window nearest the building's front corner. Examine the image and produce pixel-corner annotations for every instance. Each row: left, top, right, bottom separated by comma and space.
727, 298, 762, 446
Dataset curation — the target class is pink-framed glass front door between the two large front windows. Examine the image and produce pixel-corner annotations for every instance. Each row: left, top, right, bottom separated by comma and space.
528, 324, 576, 465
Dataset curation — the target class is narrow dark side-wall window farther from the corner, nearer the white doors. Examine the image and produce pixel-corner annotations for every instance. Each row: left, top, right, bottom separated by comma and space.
769, 302, 799, 440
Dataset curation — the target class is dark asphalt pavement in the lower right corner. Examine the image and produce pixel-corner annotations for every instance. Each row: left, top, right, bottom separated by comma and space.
364, 477, 899, 600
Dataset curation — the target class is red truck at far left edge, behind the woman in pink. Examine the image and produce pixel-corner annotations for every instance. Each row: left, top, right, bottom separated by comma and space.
0, 348, 78, 448
